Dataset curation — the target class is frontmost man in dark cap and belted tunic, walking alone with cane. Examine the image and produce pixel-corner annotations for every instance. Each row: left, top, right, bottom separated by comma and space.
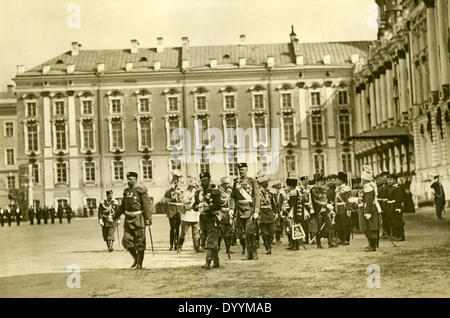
113, 172, 152, 270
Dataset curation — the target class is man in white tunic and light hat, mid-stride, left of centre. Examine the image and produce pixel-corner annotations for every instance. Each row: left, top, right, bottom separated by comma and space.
178, 180, 200, 253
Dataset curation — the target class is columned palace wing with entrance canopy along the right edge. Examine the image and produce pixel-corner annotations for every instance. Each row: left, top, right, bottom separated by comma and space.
352, 0, 450, 202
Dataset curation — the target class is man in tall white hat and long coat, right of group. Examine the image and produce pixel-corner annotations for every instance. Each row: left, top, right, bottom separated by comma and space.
361, 166, 380, 252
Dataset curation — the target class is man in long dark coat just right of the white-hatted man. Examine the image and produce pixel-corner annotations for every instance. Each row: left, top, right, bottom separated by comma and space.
388, 174, 405, 241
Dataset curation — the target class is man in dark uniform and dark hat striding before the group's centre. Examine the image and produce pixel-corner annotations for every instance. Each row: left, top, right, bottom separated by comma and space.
193, 172, 221, 269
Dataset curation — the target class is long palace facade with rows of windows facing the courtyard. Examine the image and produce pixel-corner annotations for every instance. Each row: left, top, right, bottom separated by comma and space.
14, 28, 370, 210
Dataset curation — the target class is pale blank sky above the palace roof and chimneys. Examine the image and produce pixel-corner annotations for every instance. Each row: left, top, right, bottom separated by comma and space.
0, 0, 377, 91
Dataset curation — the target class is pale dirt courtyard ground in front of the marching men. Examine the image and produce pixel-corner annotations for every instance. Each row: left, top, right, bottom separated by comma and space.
0, 208, 450, 298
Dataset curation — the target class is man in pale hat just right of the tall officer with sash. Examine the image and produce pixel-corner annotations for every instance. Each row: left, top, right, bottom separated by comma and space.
257, 174, 277, 254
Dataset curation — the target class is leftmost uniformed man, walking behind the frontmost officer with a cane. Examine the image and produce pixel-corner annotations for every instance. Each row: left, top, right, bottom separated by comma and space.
98, 190, 120, 252
